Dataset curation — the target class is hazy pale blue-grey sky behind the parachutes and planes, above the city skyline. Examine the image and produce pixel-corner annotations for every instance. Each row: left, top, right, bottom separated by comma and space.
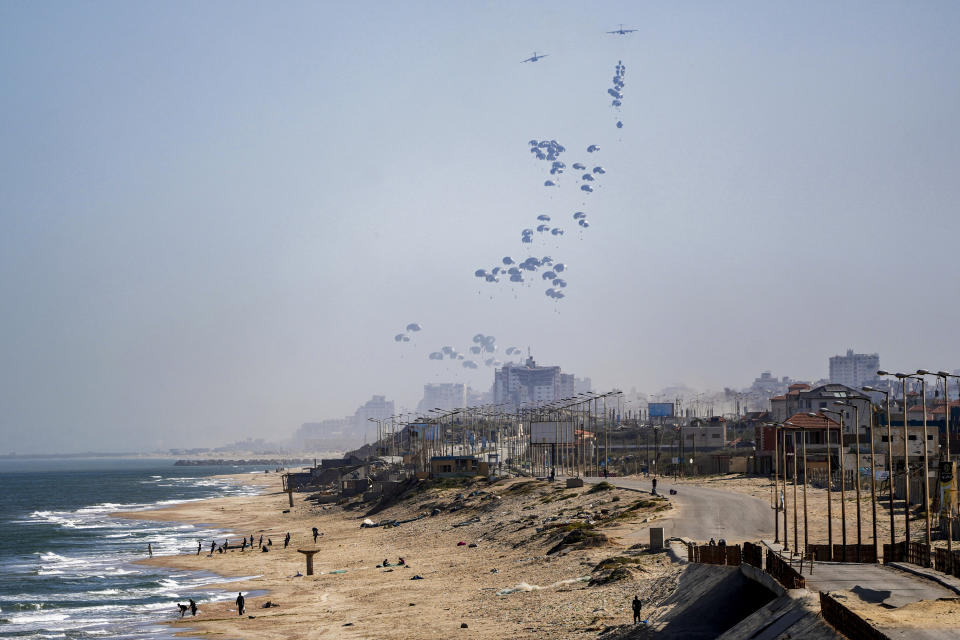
0, 0, 960, 453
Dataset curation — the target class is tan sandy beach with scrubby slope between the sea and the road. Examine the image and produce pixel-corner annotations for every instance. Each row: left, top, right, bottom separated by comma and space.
118, 474, 681, 639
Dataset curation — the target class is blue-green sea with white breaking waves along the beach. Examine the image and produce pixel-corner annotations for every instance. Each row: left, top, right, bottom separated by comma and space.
0, 457, 276, 639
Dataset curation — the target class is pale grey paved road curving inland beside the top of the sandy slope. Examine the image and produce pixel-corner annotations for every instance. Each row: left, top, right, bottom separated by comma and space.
584, 477, 773, 543
